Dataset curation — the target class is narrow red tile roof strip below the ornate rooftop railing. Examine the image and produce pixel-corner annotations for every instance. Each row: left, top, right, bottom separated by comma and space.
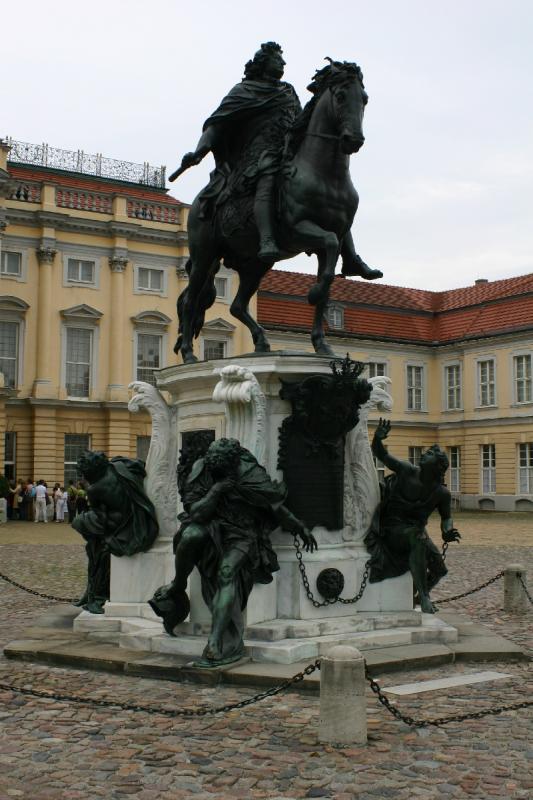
8, 162, 183, 205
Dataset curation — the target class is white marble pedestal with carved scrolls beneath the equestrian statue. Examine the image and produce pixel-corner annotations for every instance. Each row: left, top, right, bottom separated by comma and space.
75, 353, 457, 664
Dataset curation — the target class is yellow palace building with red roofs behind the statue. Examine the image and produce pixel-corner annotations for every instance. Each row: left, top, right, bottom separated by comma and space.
0, 140, 533, 511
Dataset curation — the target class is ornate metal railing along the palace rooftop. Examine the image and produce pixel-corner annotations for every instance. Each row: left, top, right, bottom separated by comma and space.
6, 137, 166, 189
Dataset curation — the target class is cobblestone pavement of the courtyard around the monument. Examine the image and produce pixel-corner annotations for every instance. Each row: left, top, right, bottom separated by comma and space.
0, 514, 533, 800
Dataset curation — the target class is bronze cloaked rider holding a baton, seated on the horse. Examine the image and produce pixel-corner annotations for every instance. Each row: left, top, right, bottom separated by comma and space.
170, 42, 382, 280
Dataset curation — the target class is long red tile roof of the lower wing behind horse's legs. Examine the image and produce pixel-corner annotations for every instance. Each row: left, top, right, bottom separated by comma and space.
258, 270, 533, 344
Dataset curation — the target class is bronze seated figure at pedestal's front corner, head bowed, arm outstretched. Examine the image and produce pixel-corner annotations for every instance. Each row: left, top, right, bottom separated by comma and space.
149, 439, 316, 667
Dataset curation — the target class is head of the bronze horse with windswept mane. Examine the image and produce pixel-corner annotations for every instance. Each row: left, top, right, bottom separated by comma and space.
307, 58, 368, 155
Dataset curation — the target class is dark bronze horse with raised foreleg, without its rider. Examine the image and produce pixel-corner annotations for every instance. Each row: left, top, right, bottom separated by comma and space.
174, 61, 370, 364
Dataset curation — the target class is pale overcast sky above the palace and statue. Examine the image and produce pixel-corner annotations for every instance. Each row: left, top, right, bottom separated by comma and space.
0, 0, 533, 289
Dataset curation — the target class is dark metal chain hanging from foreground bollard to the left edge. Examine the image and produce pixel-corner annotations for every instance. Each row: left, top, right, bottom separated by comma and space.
0, 659, 320, 717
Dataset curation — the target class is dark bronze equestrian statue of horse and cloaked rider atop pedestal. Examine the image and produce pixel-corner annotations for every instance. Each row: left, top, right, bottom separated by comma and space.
169, 42, 382, 363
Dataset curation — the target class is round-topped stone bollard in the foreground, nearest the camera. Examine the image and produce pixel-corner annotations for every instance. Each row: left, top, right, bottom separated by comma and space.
318, 645, 367, 744
